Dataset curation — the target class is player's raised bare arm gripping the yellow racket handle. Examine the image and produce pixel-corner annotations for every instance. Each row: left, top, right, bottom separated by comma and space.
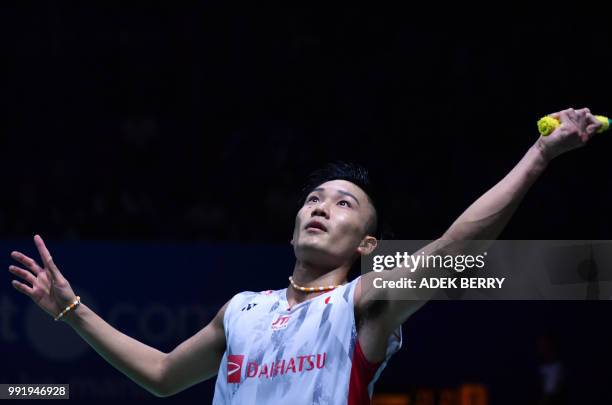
355, 109, 601, 356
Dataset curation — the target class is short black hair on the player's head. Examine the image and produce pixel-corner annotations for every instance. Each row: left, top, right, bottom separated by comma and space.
300, 161, 392, 239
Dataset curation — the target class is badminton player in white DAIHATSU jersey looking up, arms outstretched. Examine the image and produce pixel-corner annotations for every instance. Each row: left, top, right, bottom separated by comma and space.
9, 109, 601, 405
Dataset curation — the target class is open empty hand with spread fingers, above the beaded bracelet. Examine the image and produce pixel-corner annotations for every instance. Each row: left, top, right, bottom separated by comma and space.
9, 235, 76, 318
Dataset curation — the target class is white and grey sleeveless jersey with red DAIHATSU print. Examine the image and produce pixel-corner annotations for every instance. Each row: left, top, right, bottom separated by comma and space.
213, 278, 401, 405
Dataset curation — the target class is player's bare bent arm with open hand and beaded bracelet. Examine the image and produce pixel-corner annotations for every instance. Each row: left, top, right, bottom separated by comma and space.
9, 235, 227, 397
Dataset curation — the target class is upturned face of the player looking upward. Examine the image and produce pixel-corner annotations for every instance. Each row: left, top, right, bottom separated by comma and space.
291, 180, 375, 266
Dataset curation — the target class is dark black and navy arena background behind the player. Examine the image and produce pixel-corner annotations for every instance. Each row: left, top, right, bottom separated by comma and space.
0, 2, 612, 404
